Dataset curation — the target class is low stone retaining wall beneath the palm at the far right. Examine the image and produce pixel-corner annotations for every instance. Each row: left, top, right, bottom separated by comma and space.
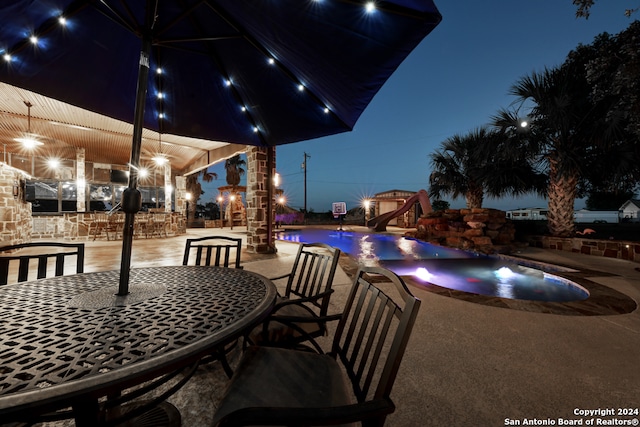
527, 236, 640, 262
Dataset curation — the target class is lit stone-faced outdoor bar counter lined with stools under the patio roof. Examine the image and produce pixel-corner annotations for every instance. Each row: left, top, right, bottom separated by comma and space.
31, 212, 186, 241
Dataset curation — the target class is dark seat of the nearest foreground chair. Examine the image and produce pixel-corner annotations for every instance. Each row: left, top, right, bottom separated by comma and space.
214, 346, 356, 425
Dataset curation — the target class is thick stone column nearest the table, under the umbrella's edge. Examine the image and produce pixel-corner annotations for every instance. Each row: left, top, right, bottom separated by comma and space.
247, 147, 276, 253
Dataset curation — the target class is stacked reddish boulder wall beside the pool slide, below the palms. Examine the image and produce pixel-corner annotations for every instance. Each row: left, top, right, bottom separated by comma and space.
415, 208, 515, 253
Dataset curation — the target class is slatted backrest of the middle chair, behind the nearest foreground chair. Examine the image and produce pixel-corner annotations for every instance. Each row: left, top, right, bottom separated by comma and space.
285, 243, 340, 316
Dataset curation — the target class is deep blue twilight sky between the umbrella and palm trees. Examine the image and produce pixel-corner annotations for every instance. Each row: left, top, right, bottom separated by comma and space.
200, 0, 637, 212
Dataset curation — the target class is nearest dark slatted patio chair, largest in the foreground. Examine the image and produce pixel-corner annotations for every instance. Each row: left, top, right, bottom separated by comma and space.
213, 267, 420, 427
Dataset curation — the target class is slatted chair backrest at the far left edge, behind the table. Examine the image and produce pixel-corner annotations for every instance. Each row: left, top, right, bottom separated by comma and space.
0, 242, 84, 285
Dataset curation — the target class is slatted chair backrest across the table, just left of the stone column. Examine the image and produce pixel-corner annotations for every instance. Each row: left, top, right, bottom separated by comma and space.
182, 236, 242, 268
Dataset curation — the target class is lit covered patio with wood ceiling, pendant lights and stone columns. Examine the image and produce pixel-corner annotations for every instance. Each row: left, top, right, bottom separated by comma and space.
0, 83, 275, 252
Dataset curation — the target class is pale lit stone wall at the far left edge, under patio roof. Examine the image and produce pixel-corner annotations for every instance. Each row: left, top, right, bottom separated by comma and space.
0, 163, 31, 245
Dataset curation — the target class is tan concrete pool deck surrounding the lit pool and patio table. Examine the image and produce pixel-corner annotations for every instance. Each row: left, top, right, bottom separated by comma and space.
11, 227, 640, 427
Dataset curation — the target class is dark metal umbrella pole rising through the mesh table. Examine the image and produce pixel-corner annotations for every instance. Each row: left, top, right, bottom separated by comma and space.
118, 20, 153, 296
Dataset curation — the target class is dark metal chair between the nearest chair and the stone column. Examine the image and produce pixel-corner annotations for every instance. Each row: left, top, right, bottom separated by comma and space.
245, 243, 340, 348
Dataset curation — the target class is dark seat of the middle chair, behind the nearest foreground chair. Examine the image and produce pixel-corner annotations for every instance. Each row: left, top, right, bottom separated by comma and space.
249, 297, 326, 347
